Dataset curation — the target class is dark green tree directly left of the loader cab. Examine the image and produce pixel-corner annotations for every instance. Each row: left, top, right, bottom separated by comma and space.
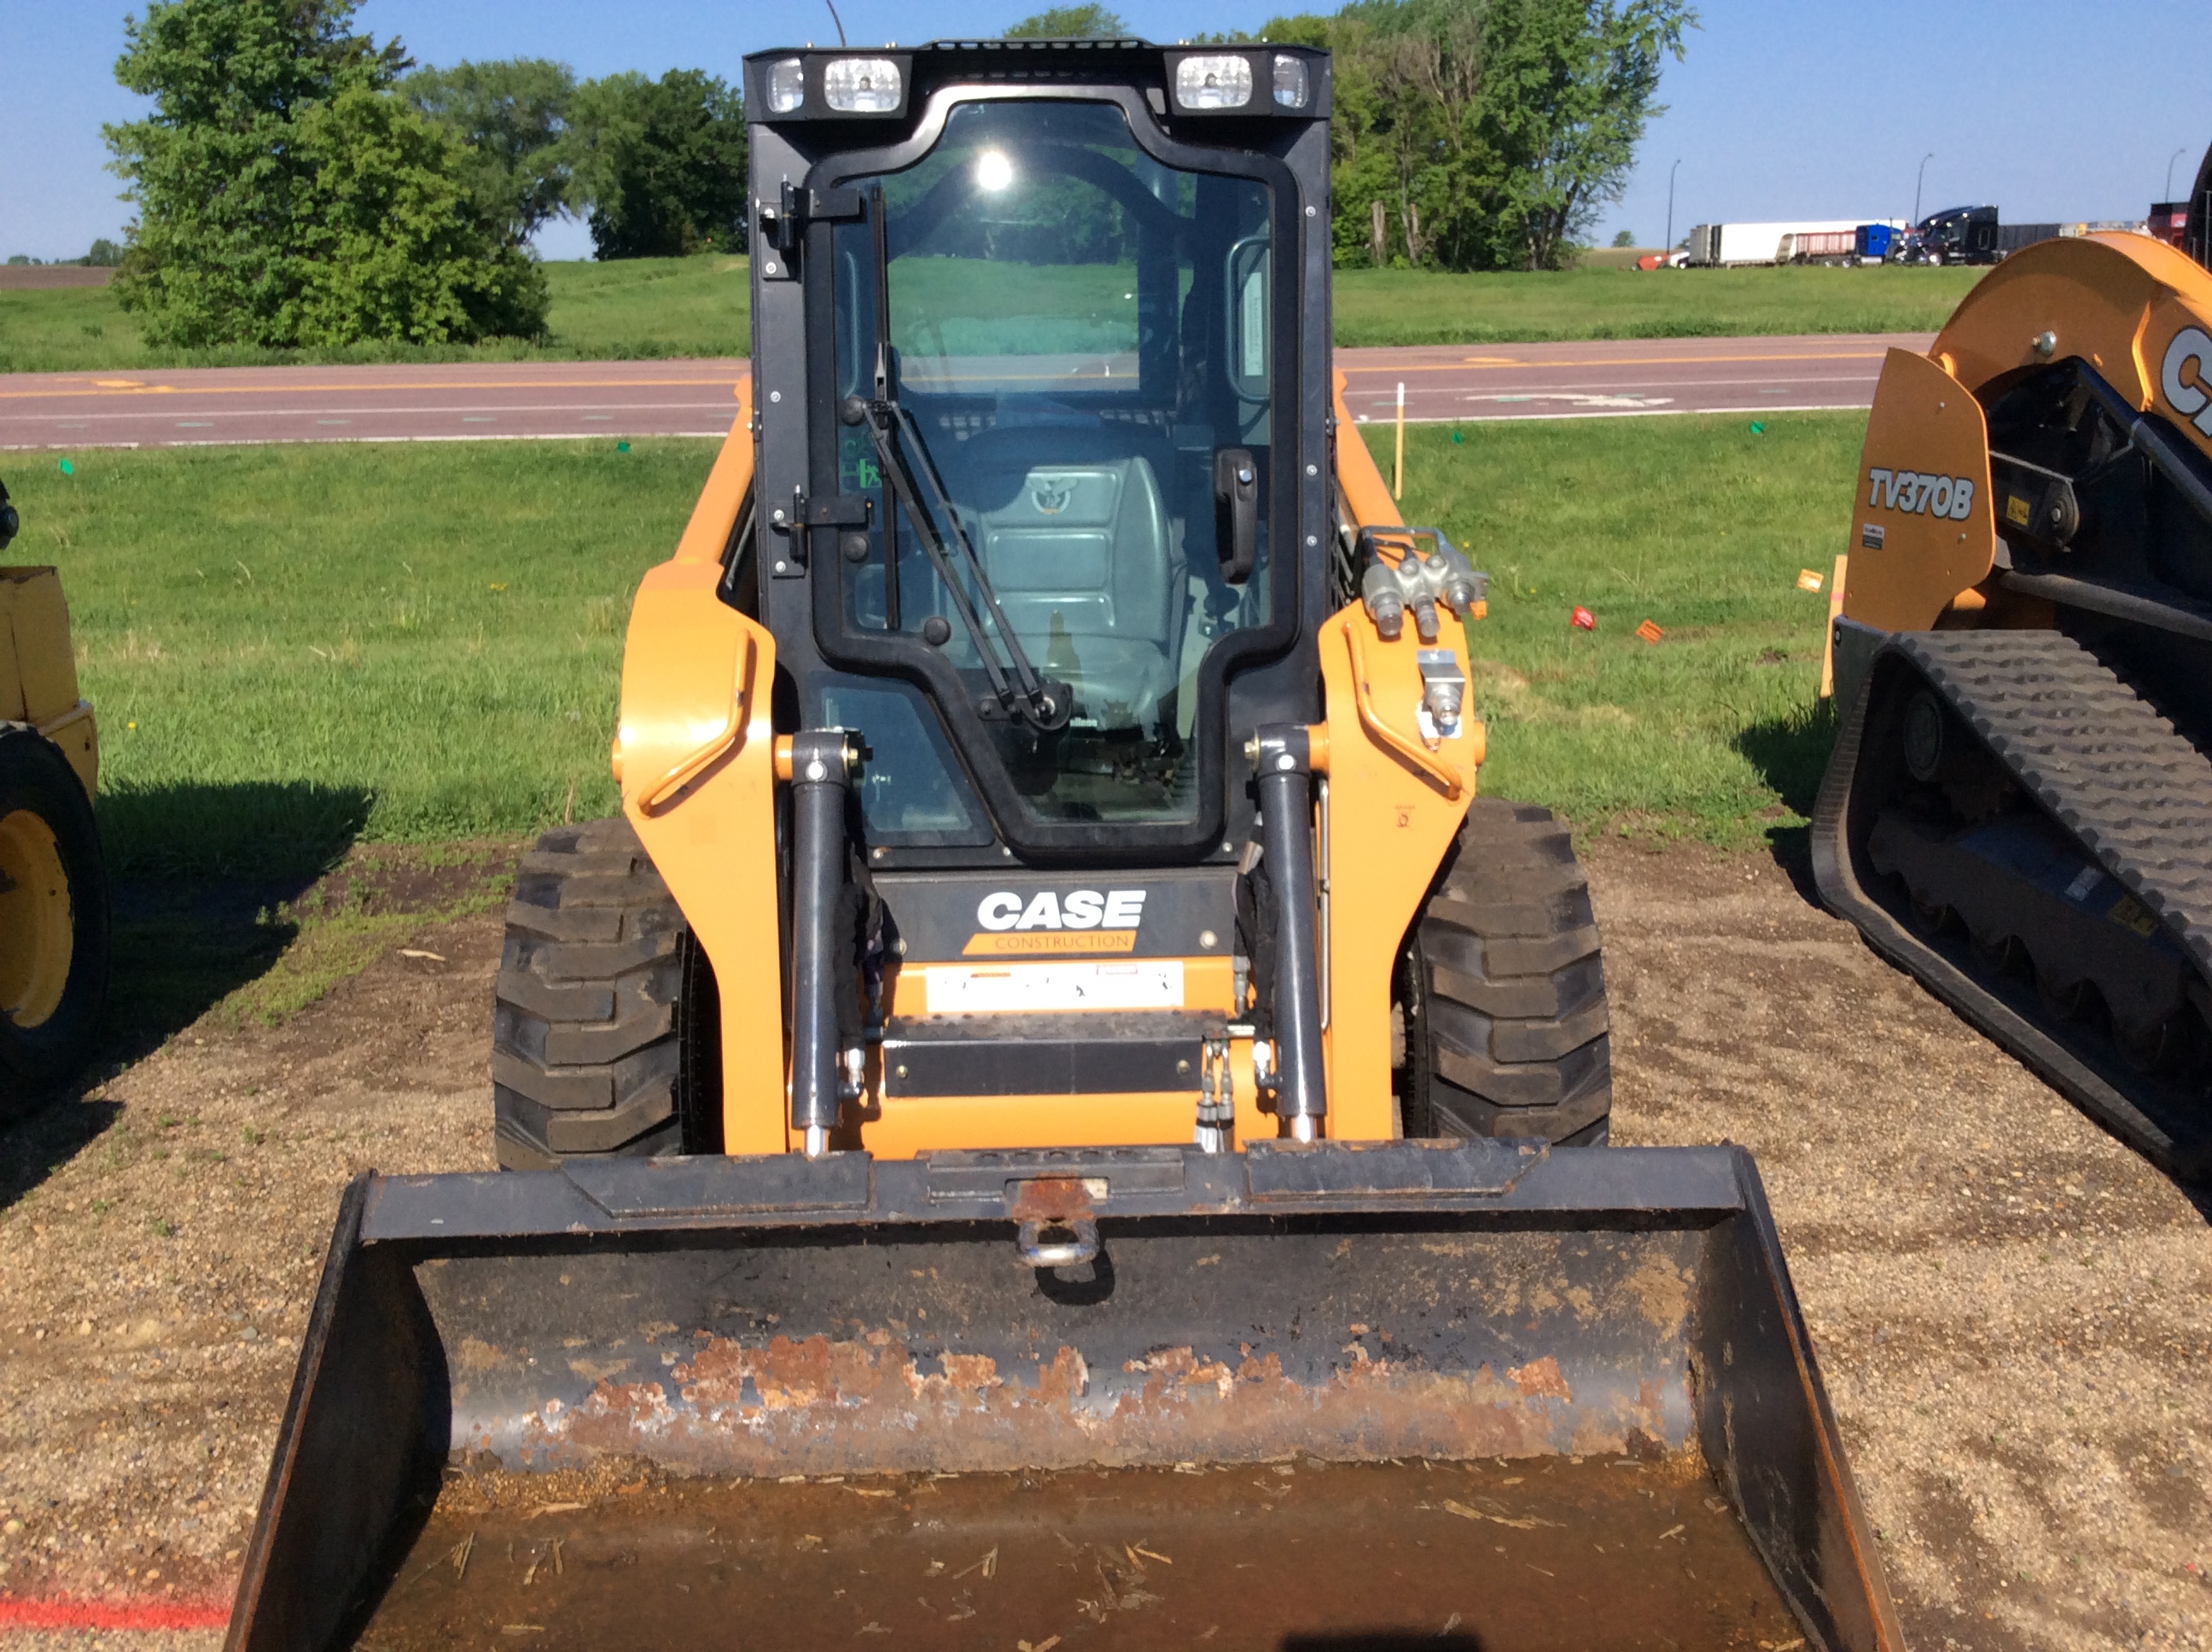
568, 68, 746, 259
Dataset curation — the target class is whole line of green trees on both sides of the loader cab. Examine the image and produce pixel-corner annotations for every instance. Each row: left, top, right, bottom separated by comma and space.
106, 0, 1694, 349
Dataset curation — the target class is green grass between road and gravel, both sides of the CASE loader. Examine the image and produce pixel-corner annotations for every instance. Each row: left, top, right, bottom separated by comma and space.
9, 414, 1860, 1034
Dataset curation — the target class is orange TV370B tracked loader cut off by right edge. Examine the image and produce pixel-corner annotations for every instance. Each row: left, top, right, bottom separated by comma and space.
1813, 235, 2212, 1178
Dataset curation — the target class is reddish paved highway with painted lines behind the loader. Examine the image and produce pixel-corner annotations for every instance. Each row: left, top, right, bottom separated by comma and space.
0, 334, 1929, 449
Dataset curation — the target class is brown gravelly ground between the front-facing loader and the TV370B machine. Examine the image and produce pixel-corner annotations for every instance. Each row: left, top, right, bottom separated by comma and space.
1591, 842, 2212, 1652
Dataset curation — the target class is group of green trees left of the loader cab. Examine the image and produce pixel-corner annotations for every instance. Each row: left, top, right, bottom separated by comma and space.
106, 0, 746, 349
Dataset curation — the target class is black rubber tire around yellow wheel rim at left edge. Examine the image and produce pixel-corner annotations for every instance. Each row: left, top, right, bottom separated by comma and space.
0, 730, 108, 1119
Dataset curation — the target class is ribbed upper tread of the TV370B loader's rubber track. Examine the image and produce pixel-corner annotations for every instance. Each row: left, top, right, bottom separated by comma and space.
1894, 631, 2212, 975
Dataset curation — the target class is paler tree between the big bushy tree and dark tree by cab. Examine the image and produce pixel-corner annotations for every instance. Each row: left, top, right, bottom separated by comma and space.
400, 57, 575, 246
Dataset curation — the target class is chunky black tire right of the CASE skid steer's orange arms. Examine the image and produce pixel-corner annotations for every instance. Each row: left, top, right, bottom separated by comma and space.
1396, 799, 1613, 1148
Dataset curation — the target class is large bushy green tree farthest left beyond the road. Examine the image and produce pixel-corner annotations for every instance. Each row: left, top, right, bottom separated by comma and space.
106, 0, 546, 347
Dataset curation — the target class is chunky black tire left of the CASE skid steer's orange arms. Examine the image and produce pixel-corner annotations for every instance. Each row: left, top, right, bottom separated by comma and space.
491, 818, 719, 1170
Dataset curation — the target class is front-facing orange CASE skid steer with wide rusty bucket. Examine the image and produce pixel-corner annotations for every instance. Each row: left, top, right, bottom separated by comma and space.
230, 42, 1898, 1648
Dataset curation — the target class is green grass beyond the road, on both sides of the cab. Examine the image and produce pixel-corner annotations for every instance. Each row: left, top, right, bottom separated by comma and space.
0, 254, 1980, 371
